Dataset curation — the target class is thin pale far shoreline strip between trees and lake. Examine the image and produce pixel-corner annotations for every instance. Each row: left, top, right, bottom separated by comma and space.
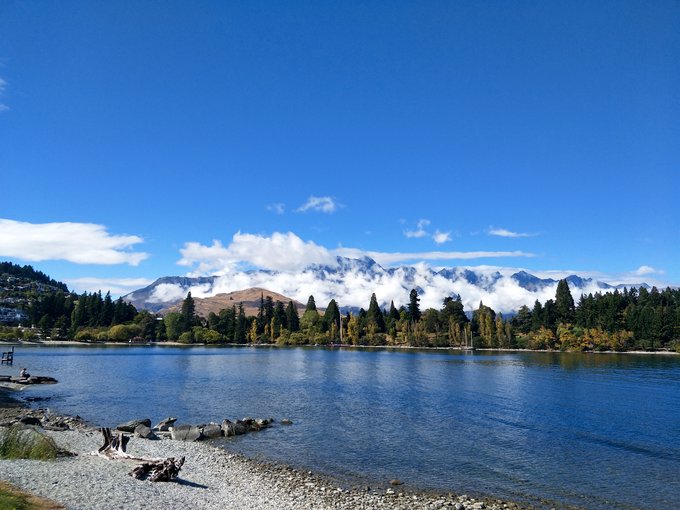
0, 340, 680, 356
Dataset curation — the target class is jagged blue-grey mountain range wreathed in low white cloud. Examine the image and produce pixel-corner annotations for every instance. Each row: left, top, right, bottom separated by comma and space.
124, 257, 647, 313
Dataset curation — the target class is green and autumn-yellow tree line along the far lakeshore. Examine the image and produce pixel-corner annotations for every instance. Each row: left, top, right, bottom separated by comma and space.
0, 263, 680, 352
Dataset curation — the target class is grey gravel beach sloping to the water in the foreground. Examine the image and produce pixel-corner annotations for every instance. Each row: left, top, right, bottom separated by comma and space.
0, 408, 528, 510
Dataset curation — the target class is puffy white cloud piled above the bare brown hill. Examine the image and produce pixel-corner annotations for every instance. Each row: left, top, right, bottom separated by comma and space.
178, 232, 335, 274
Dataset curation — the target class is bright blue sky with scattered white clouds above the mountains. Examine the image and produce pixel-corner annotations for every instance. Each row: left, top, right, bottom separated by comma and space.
0, 1, 680, 293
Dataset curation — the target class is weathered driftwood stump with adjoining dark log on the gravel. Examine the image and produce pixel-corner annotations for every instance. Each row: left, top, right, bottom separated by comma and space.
97, 428, 184, 482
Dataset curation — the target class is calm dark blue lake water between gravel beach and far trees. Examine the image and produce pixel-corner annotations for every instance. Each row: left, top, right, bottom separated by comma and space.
0, 347, 680, 509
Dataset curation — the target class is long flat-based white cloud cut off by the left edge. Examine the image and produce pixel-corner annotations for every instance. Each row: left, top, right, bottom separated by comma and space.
0, 219, 149, 266
